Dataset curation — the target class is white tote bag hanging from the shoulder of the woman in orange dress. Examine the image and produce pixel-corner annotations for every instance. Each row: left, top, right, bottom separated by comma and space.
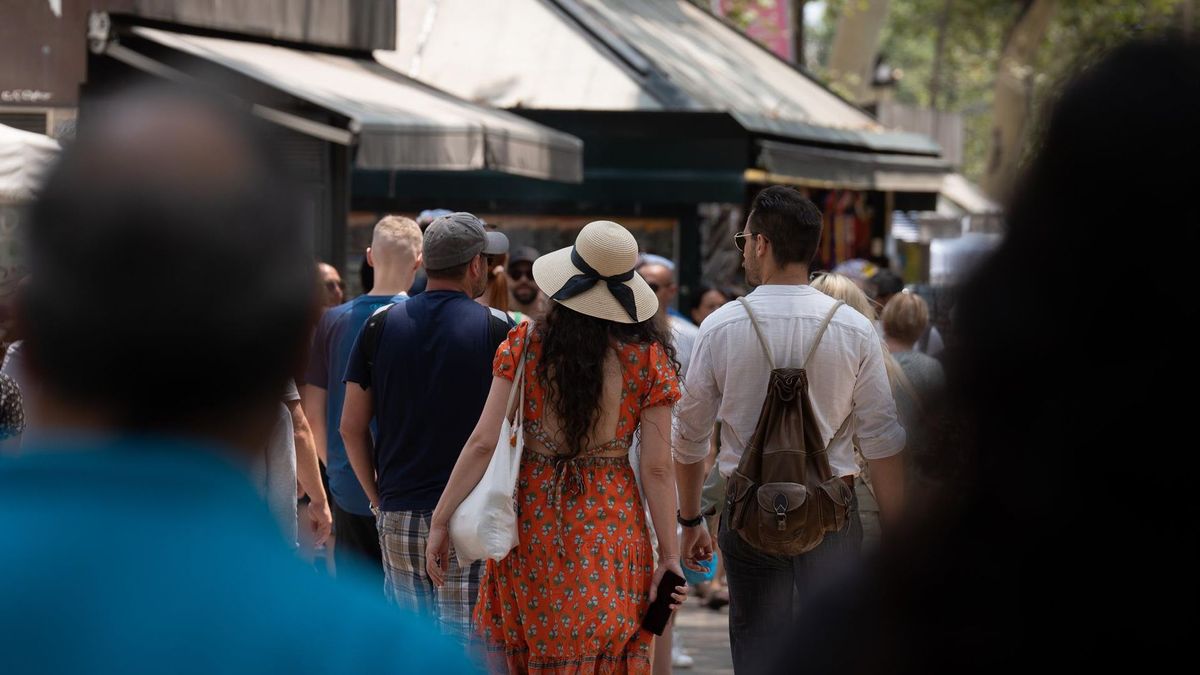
450, 352, 526, 567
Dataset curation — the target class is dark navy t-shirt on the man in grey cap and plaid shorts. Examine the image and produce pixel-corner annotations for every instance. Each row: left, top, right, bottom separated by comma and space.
346, 291, 504, 510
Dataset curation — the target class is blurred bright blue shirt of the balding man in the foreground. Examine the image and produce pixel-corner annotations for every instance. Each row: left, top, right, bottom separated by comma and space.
0, 440, 475, 675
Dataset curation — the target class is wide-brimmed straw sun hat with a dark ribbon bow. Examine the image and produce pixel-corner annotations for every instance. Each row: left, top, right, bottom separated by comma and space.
533, 220, 659, 323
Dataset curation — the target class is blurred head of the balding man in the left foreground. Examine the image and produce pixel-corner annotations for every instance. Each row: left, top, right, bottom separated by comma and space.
23, 89, 316, 432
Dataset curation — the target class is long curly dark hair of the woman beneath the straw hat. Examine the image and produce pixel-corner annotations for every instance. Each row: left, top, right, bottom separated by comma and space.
534, 303, 679, 456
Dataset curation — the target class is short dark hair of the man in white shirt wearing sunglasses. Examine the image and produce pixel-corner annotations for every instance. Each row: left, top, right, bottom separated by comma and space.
746, 185, 822, 265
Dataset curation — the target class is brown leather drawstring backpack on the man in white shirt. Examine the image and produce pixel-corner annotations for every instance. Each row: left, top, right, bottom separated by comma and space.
726, 298, 854, 556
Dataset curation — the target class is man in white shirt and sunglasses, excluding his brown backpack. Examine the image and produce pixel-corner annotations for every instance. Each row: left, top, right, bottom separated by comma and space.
674, 187, 905, 673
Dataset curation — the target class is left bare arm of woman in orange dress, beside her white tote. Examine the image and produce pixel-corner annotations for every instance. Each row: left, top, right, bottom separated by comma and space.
425, 377, 512, 586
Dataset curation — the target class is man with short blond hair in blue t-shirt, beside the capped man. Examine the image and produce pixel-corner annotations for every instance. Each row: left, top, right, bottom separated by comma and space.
305, 216, 421, 581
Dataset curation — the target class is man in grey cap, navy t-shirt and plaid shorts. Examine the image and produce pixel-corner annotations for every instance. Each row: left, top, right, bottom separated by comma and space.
342, 213, 511, 641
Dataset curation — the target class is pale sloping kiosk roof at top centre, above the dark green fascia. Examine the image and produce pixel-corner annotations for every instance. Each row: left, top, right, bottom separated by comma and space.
376, 0, 940, 155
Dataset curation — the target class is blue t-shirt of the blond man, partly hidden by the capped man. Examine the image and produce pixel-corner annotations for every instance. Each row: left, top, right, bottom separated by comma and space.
305, 294, 408, 515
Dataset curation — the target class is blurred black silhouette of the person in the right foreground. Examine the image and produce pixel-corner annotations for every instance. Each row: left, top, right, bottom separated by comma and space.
779, 41, 1200, 673
